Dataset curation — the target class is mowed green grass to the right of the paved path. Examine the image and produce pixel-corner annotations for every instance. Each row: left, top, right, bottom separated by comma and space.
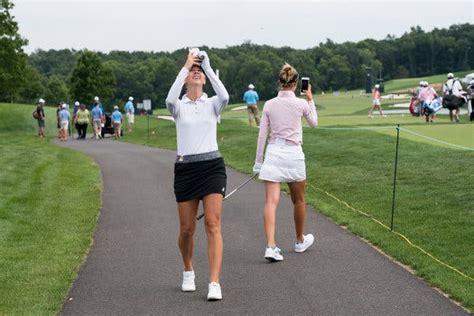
123, 93, 474, 310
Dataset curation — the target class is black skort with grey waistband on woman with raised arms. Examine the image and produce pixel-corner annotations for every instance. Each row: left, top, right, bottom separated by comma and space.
174, 157, 227, 202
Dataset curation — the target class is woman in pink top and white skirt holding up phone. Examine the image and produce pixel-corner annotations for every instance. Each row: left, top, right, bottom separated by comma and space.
253, 64, 318, 262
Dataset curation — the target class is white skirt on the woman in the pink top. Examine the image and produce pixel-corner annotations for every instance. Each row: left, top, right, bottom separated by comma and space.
258, 139, 306, 182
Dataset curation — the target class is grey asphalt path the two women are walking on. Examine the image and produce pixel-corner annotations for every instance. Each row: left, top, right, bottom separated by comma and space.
58, 139, 467, 315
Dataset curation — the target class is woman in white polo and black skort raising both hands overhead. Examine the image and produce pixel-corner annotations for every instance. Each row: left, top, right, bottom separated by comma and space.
166, 51, 229, 300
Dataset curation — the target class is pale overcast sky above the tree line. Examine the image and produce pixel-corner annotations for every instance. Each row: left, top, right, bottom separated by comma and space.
12, 0, 474, 53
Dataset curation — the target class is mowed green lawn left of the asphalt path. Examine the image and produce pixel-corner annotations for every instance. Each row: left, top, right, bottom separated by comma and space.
0, 104, 102, 315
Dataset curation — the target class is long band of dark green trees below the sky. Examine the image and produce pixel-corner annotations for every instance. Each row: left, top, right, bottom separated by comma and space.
0, 0, 474, 107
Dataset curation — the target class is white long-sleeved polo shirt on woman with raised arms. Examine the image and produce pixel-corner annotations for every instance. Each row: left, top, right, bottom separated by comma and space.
166, 67, 229, 156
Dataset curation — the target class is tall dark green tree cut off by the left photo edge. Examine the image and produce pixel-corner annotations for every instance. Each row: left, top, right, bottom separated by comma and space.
0, 0, 28, 102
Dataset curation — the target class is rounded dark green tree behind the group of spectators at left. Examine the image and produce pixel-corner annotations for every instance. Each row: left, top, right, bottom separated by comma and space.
70, 50, 116, 108
